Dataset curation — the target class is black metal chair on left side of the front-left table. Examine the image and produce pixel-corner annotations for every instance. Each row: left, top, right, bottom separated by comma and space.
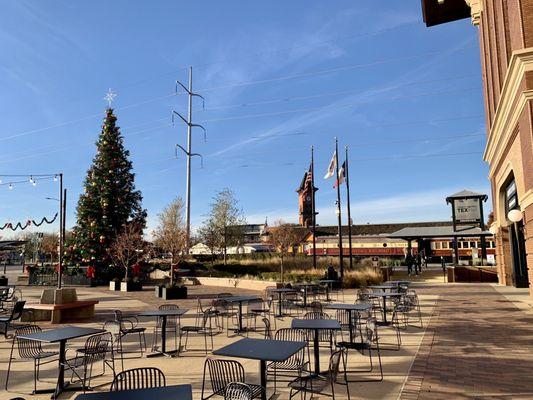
5, 325, 59, 392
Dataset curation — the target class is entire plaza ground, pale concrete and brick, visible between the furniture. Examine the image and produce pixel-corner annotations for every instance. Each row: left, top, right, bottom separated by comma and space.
0, 283, 533, 399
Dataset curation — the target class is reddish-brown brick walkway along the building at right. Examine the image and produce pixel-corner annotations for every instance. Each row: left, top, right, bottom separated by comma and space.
399, 284, 533, 400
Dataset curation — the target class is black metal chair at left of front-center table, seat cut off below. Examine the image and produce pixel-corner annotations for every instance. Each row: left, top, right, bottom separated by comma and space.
200, 357, 265, 400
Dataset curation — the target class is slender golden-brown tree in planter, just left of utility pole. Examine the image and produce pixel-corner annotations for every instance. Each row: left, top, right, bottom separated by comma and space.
154, 197, 187, 285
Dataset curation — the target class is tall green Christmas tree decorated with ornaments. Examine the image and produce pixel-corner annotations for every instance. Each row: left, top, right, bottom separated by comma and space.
67, 108, 146, 272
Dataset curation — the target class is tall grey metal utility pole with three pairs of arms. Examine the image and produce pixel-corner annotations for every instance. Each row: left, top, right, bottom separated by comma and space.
172, 67, 206, 254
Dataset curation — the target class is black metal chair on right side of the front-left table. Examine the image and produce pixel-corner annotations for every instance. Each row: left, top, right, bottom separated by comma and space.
65, 332, 116, 391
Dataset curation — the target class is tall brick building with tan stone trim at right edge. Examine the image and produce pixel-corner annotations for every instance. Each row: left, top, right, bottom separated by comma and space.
422, 0, 533, 295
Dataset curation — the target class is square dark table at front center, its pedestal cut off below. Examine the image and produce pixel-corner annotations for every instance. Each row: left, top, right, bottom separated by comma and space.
213, 338, 307, 400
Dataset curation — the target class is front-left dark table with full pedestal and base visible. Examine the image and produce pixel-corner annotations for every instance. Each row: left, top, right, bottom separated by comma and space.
19, 326, 105, 399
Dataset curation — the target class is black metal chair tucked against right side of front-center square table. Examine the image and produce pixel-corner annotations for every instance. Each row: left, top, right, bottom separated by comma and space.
267, 328, 309, 390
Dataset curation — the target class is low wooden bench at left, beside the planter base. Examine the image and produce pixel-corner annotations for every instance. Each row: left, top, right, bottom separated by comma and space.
27, 300, 99, 324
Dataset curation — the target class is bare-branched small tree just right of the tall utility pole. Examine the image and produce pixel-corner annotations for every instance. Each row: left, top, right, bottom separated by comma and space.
204, 188, 246, 265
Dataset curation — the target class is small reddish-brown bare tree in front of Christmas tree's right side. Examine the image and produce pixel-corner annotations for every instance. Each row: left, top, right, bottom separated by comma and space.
110, 223, 146, 281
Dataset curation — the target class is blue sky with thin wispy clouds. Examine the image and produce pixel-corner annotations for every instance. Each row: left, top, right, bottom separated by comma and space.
0, 0, 491, 235
